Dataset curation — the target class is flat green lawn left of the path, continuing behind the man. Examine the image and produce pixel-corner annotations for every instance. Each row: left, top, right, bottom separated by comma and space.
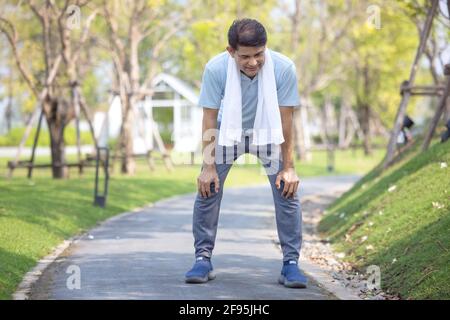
0, 146, 382, 299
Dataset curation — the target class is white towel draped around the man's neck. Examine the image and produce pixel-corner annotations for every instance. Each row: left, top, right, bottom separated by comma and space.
219, 48, 284, 147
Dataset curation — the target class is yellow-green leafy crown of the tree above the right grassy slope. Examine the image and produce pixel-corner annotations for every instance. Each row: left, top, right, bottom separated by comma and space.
348, 1, 420, 126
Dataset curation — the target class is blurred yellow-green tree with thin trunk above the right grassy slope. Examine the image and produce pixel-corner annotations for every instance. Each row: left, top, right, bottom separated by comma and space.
338, 1, 417, 155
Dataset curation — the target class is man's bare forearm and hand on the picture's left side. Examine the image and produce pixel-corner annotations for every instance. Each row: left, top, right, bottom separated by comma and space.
197, 108, 219, 197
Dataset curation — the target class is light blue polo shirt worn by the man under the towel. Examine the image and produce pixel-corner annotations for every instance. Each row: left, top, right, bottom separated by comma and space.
198, 50, 300, 129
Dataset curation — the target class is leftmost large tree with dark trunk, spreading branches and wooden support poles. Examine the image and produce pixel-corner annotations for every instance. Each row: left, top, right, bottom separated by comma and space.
0, 0, 96, 178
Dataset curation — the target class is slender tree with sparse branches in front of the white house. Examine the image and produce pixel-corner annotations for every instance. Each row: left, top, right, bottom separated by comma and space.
97, 0, 192, 175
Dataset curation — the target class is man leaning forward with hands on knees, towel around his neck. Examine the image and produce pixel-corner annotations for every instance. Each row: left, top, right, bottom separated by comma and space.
185, 19, 307, 288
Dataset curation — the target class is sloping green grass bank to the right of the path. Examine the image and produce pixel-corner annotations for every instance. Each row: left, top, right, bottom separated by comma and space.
319, 141, 450, 299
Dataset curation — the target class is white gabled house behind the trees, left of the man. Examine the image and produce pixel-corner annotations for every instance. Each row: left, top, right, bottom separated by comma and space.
94, 73, 202, 154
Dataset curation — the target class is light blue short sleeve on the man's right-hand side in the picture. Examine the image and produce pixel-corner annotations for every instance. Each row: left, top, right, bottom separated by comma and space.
277, 64, 300, 107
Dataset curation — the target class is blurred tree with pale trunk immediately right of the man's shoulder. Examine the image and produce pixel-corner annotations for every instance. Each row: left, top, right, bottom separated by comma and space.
282, 0, 357, 160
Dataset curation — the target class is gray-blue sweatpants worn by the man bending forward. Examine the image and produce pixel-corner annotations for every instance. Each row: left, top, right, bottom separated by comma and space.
192, 132, 302, 261
